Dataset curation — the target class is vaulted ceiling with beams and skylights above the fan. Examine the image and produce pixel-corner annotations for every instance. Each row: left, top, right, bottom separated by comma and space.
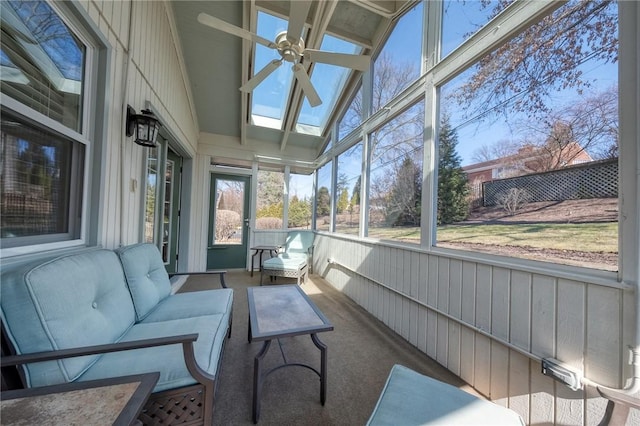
172, 0, 414, 169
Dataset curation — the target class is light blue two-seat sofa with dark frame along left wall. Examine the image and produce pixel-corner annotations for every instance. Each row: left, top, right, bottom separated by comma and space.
0, 244, 233, 424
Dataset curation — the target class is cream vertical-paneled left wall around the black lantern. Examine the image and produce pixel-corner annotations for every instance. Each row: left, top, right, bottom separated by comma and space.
80, 0, 199, 248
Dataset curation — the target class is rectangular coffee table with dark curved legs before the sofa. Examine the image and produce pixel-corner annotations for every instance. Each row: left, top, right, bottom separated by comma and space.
247, 285, 333, 423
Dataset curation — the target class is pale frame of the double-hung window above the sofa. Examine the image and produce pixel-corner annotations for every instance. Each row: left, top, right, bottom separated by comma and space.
0, 1, 106, 259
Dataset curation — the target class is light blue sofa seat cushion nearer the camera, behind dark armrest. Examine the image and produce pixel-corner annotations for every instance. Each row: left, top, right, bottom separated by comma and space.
79, 312, 230, 392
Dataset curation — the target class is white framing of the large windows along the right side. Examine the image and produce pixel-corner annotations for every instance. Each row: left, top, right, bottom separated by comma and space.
313, 1, 640, 286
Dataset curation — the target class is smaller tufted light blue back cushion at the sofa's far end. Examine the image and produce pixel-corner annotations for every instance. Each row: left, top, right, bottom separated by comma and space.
116, 243, 171, 321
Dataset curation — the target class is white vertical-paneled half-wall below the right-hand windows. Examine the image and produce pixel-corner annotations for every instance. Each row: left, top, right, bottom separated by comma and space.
314, 234, 637, 425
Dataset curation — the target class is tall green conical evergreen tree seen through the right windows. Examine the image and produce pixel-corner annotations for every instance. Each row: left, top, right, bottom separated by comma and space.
438, 115, 469, 225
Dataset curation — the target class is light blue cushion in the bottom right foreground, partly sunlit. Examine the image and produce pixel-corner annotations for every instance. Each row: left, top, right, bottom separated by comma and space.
367, 365, 524, 426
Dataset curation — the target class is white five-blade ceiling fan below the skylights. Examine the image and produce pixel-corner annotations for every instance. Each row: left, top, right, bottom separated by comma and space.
198, 1, 371, 107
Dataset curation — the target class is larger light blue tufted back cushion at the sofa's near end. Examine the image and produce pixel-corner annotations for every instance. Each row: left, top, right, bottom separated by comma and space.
0, 250, 135, 386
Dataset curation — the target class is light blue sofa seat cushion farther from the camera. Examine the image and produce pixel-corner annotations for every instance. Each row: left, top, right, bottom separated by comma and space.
143, 288, 233, 322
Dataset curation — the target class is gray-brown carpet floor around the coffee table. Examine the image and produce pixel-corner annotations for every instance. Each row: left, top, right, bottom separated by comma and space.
180, 271, 473, 425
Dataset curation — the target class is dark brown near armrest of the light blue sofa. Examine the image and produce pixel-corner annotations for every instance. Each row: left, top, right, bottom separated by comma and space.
0, 333, 215, 392
